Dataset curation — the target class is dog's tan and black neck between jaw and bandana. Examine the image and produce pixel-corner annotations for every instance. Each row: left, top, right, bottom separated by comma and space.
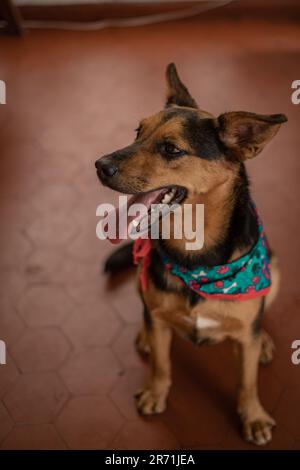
158, 164, 257, 269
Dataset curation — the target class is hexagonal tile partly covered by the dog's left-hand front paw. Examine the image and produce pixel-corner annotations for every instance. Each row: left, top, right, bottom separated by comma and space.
109, 367, 148, 420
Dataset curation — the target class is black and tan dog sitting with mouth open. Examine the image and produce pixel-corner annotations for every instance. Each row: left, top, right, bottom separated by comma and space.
96, 64, 286, 445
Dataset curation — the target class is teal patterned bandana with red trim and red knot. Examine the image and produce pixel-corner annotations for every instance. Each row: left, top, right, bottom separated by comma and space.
133, 206, 271, 300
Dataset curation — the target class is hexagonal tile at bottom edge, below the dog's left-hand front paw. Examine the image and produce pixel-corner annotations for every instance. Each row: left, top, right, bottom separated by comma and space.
110, 418, 180, 450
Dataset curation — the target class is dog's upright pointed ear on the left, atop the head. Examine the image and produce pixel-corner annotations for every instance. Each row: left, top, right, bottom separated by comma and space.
166, 63, 198, 108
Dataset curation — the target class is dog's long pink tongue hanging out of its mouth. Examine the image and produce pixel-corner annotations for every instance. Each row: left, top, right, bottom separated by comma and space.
104, 188, 167, 244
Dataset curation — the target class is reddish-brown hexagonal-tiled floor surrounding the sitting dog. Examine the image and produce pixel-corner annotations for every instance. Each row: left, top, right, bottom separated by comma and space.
0, 15, 300, 449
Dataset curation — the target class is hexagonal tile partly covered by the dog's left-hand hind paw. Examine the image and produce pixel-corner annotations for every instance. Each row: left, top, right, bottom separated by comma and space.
112, 325, 144, 368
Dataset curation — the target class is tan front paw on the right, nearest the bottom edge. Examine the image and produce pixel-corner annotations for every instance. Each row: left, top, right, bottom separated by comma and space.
243, 413, 276, 446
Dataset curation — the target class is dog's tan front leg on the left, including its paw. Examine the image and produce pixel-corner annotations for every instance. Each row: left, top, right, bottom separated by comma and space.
135, 311, 172, 415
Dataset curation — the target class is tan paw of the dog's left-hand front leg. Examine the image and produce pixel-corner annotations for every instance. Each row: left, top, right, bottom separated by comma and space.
134, 387, 168, 415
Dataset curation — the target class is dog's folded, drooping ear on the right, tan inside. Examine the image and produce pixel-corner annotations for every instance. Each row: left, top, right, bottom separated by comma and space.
217, 111, 287, 160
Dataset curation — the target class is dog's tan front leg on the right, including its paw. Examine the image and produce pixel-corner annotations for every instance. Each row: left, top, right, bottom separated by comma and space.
238, 334, 275, 445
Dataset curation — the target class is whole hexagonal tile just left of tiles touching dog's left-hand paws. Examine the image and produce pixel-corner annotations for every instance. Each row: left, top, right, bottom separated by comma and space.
60, 348, 121, 395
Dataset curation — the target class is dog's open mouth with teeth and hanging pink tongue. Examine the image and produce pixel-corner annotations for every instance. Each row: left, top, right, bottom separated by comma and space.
105, 185, 187, 243
